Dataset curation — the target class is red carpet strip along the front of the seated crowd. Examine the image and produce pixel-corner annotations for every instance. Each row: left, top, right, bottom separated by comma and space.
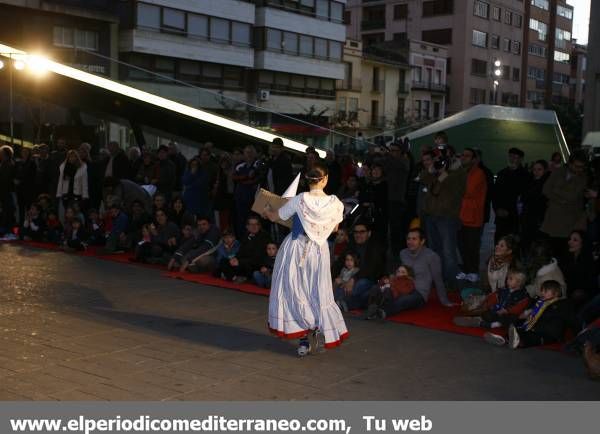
4, 241, 562, 350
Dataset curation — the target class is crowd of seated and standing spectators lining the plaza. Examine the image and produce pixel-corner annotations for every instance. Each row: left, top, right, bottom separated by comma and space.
0, 133, 600, 376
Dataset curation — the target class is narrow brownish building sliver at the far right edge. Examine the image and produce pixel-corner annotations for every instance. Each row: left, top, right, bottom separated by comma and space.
583, 0, 600, 136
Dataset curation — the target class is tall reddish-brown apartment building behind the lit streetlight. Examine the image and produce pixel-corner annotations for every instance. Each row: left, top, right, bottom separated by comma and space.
345, 0, 525, 113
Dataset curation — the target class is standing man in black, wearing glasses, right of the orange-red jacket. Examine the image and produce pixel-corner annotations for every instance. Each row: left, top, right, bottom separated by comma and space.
492, 148, 529, 242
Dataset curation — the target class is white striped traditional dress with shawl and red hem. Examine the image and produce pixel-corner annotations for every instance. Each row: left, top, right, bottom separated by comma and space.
269, 193, 348, 348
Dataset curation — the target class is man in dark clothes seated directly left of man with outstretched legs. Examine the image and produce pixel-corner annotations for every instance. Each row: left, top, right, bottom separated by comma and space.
134, 209, 179, 264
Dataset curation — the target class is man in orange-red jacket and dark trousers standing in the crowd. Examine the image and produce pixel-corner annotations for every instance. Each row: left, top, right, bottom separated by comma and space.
456, 148, 488, 282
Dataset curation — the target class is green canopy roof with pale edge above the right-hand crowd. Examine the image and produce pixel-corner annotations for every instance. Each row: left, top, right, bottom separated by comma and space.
407, 105, 569, 172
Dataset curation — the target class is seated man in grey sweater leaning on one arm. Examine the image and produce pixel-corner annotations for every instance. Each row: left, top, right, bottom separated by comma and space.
395, 229, 454, 306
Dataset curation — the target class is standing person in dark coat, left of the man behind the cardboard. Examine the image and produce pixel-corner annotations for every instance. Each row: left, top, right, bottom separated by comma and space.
233, 146, 262, 237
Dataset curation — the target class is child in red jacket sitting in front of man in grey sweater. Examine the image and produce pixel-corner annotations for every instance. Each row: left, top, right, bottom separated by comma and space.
365, 265, 415, 320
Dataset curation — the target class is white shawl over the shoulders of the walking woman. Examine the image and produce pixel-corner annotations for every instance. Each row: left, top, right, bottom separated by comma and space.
279, 193, 344, 245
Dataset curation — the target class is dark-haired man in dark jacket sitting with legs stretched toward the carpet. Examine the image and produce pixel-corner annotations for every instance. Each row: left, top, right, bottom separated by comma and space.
167, 216, 220, 273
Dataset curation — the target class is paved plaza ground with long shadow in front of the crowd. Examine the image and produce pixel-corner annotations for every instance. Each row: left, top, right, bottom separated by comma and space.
0, 244, 600, 400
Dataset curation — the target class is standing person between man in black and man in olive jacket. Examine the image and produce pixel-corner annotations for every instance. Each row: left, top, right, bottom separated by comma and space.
521, 160, 550, 253
